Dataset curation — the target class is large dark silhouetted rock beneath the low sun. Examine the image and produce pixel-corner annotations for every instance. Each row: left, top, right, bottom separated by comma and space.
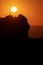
0, 14, 30, 40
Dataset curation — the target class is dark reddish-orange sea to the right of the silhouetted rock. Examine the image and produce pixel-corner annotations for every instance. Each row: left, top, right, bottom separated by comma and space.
28, 25, 43, 39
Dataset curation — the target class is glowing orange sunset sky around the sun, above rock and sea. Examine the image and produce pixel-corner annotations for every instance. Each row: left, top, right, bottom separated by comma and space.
0, 0, 43, 25
